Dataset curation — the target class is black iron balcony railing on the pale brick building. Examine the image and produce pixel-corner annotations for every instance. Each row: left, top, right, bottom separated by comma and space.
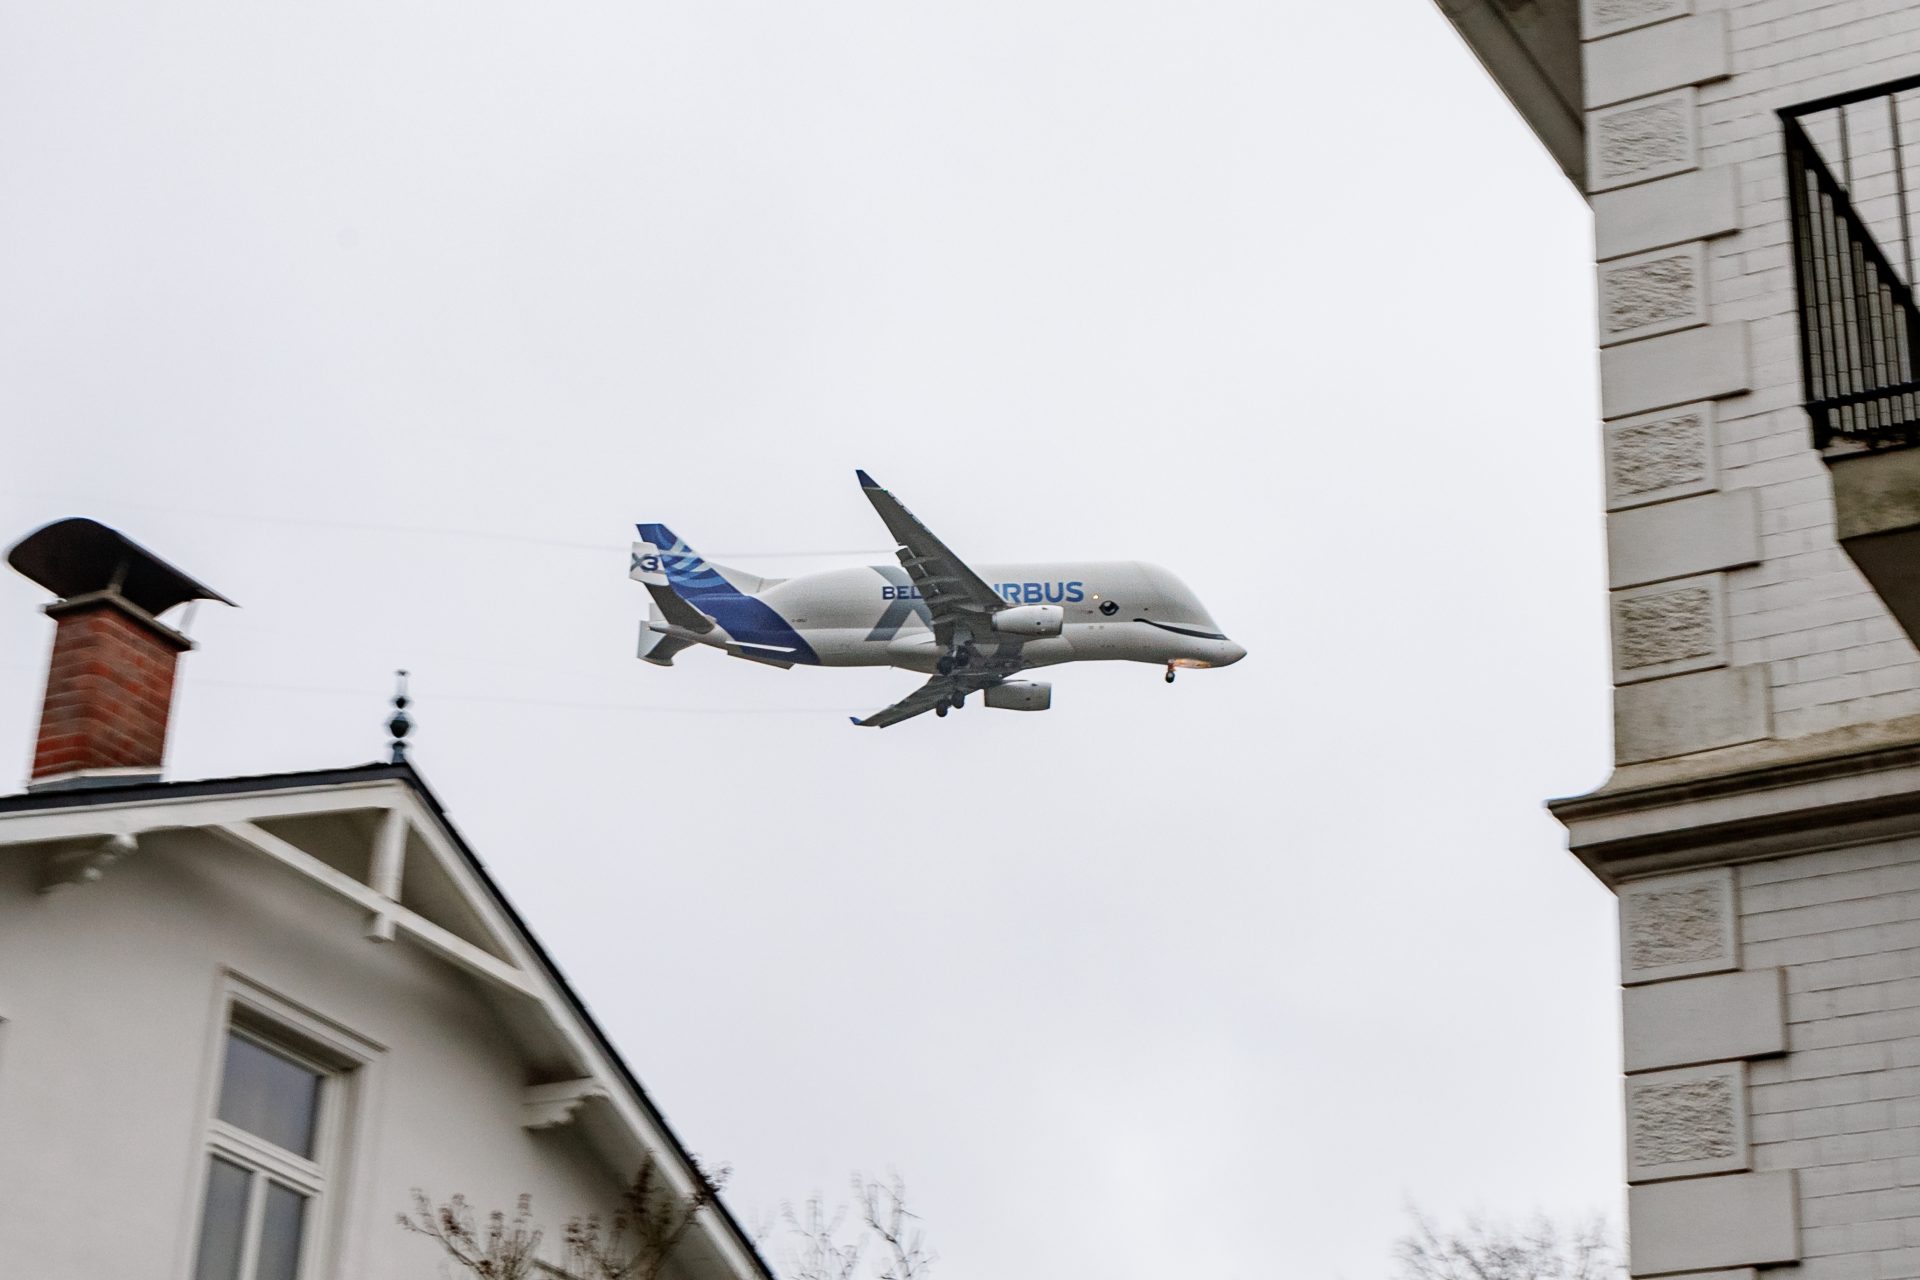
1780, 77, 1920, 451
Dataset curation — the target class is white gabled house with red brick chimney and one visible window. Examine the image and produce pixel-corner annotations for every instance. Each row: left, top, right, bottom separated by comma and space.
0, 520, 770, 1280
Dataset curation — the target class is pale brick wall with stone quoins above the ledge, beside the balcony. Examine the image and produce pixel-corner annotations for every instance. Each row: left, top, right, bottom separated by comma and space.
1582, 0, 1920, 764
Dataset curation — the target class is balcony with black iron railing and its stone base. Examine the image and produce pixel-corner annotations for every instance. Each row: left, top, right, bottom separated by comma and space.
1780, 77, 1920, 639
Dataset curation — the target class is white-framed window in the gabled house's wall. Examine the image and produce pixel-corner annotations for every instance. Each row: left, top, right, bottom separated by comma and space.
194, 1009, 346, 1280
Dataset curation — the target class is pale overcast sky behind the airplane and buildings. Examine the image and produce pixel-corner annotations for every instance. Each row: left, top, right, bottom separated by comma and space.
0, 0, 1620, 1280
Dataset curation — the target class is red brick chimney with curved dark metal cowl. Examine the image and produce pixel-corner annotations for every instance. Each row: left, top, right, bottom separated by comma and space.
8, 518, 232, 791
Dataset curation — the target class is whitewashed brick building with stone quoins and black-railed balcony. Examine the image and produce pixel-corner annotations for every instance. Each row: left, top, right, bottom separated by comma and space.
1440, 0, 1920, 1280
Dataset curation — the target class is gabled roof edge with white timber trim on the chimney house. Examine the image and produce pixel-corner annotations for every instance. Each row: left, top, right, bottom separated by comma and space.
0, 764, 772, 1280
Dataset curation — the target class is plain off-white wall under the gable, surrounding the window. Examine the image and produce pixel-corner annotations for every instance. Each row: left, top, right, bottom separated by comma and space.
0, 833, 652, 1280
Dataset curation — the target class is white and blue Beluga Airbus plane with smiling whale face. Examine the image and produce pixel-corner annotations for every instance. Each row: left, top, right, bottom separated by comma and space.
628, 470, 1246, 729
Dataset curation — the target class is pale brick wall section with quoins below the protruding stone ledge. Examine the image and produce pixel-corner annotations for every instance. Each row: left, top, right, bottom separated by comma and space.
1619, 839, 1920, 1280
